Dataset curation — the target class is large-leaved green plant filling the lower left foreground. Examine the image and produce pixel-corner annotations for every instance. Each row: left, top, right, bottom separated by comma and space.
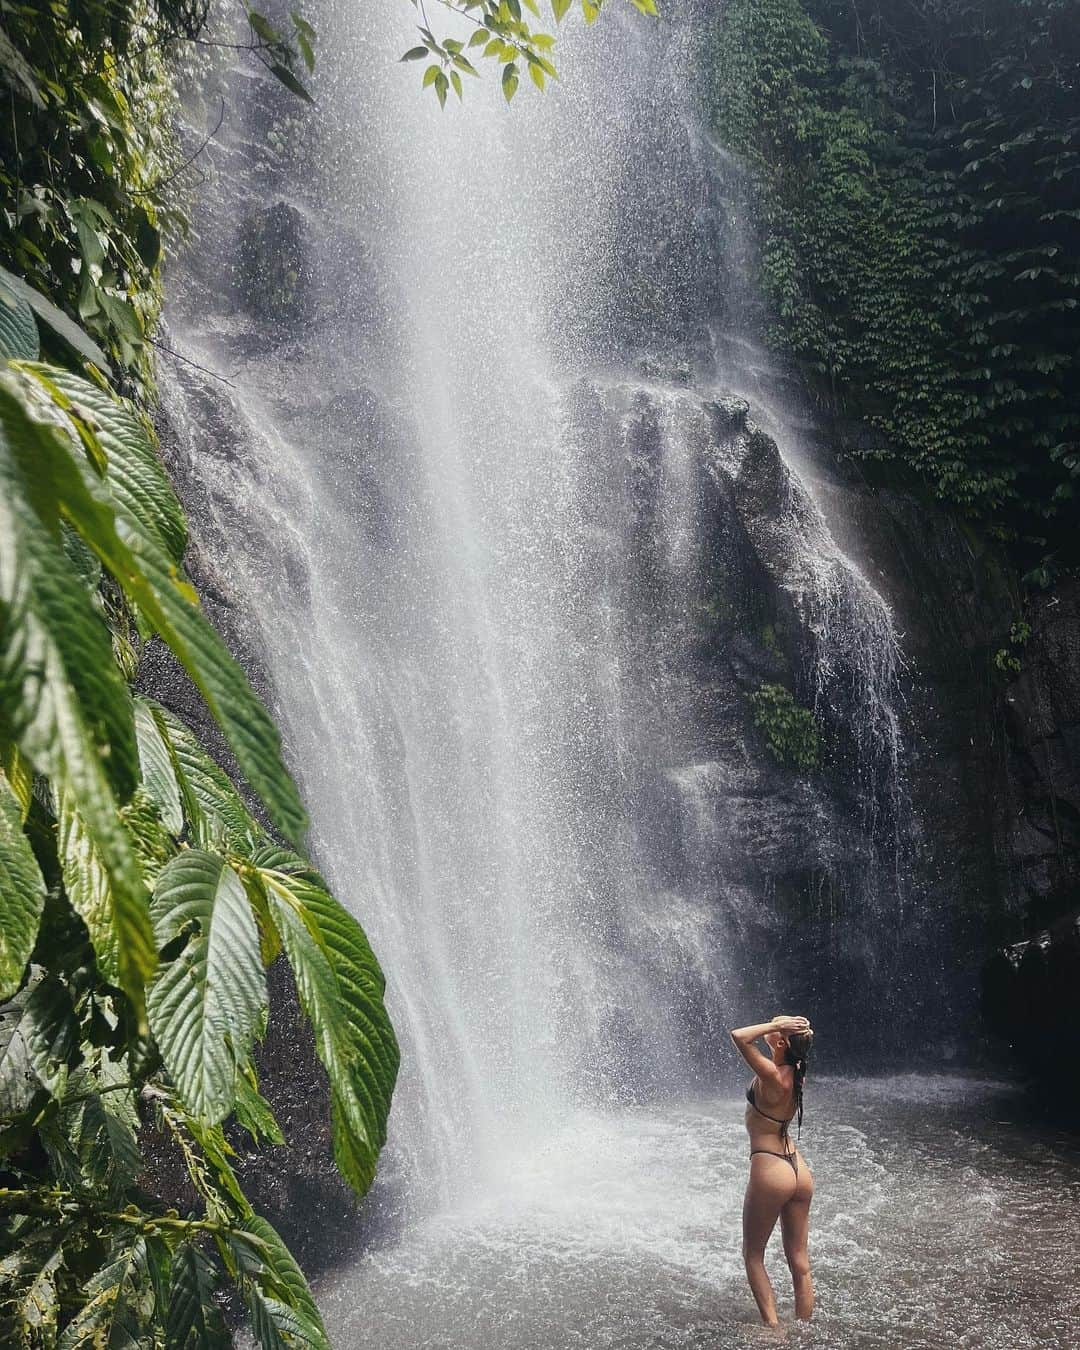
0, 36, 398, 1350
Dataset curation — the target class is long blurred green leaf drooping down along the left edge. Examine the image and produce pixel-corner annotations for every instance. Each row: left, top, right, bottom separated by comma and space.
0, 374, 157, 1010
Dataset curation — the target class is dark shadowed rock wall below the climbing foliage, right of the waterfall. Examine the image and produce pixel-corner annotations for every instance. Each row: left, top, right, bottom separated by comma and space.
799, 413, 1080, 1096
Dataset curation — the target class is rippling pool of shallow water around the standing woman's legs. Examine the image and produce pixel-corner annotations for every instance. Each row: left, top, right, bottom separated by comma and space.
319, 1076, 1080, 1350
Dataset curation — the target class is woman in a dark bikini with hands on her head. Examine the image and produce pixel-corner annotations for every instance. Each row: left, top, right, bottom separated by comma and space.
732, 1017, 814, 1327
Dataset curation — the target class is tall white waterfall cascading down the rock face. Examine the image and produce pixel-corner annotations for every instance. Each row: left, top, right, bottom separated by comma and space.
163, 0, 1080, 1347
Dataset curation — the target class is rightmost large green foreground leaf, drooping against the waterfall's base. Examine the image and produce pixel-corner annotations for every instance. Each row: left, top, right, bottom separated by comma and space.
255, 851, 398, 1195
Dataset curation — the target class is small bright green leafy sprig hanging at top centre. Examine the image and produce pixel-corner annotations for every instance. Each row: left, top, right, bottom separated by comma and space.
401, 0, 659, 108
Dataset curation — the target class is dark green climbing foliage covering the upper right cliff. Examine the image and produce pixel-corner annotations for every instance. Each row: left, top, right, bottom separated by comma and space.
713, 0, 1080, 567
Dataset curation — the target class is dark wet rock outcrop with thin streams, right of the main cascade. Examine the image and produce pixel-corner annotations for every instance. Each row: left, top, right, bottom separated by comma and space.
561, 377, 934, 1072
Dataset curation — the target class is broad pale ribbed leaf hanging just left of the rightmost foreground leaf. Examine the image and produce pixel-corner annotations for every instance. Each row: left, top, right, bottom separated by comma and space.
147, 849, 266, 1123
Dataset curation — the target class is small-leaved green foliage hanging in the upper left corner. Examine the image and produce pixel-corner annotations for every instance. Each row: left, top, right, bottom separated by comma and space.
0, 0, 174, 399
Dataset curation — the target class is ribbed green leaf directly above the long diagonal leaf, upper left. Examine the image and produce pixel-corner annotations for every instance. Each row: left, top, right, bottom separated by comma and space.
27, 366, 188, 564
